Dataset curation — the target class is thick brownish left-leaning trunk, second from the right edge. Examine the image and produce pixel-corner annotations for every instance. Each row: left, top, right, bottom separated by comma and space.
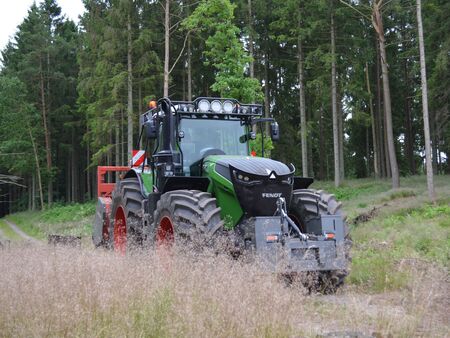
372, 0, 400, 189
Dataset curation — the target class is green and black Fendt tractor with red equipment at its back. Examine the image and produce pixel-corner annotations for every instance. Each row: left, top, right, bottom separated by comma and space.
93, 97, 351, 290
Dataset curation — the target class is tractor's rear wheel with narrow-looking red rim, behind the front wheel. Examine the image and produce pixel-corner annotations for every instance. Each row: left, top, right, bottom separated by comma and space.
109, 177, 144, 254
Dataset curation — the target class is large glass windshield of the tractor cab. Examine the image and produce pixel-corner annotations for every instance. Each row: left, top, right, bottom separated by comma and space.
179, 119, 248, 174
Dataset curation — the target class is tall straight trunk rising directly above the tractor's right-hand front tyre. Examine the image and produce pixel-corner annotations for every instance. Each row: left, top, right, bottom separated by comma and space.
331, 14, 341, 187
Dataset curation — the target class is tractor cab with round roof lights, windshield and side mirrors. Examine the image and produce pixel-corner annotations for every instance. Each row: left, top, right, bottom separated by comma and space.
141, 97, 279, 181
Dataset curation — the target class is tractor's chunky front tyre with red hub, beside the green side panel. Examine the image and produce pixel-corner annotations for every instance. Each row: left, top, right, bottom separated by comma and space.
150, 190, 223, 249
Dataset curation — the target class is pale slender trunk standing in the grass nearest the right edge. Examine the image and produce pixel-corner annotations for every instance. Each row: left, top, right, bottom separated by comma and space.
417, 0, 436, 202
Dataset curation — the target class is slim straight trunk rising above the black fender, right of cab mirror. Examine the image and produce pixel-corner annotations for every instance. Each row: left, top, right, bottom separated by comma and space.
297, 35, 308, 177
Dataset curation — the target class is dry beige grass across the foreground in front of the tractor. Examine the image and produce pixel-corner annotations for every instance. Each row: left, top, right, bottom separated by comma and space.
0, 246, 450, 337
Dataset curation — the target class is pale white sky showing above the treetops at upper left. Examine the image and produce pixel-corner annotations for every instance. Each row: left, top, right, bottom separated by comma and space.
0, 0, 84, 50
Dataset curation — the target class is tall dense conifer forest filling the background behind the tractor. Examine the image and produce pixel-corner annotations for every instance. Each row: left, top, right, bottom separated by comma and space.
0, 0, 450, 214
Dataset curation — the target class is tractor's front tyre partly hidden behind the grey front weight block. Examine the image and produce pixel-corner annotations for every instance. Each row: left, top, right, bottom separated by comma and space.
289, 189, 352, 293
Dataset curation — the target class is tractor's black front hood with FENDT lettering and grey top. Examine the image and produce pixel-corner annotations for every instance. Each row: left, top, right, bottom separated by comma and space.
205, 156, 295, 217
